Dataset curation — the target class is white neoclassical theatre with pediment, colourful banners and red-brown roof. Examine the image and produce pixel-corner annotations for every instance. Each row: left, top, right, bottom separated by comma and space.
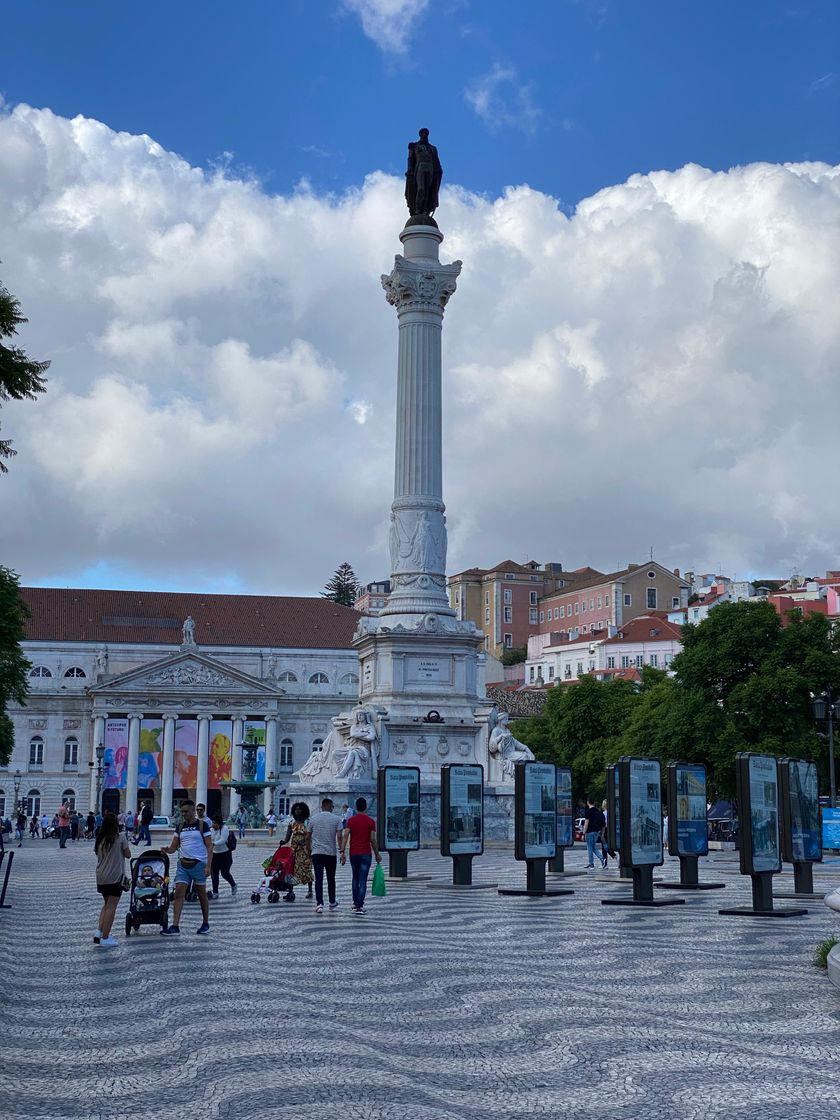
0, 587, 360, 816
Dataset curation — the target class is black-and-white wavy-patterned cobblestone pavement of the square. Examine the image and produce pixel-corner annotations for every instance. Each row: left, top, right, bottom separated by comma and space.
0, 841, 840, 1120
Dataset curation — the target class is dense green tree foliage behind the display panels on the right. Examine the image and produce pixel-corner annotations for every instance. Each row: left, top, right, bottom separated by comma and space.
514, 603, 840, 795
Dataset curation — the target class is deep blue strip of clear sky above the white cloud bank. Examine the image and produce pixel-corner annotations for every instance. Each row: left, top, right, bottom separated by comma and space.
6, 0, 840, 206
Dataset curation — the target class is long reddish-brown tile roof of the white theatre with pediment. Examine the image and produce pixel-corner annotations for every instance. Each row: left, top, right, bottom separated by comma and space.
20, 587, 360, 650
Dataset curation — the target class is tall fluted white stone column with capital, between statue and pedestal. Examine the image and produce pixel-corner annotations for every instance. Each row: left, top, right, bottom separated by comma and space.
380, 218, 461, 626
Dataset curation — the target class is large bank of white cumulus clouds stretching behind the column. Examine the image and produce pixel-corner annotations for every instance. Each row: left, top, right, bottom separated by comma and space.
0, 105, 840, 594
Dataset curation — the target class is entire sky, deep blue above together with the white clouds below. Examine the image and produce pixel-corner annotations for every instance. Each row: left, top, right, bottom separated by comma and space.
0, 0, 840, 595
